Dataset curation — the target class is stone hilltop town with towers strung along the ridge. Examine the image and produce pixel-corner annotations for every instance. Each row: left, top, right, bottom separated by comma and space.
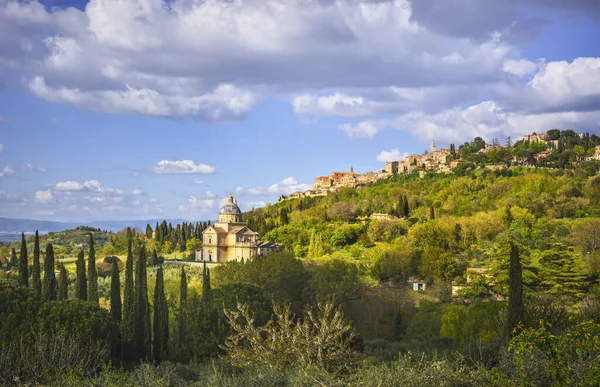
281, 129, 600, 200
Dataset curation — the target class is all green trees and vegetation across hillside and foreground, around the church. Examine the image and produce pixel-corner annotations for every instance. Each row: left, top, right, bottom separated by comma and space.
0, 131, 600, 386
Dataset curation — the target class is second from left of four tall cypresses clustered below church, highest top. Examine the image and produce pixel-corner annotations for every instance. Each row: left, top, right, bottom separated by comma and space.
121, 239, 135, 361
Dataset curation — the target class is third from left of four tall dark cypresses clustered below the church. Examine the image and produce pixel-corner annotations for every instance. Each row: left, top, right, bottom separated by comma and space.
135, 247, 152, 360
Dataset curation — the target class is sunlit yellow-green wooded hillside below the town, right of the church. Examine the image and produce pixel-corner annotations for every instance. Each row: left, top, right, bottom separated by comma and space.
245, 166, 600, 297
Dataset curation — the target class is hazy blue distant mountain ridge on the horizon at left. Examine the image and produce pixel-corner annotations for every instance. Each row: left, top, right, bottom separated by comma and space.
0, 218, 200, 236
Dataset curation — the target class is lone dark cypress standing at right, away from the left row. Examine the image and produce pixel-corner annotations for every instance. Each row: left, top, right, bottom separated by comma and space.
506, 243, 524, 339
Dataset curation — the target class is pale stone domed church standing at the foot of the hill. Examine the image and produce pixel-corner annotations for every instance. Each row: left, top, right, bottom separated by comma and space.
196, 195, 283, 262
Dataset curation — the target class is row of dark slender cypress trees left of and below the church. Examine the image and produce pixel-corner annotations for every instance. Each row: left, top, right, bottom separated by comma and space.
18, 231, 199, 362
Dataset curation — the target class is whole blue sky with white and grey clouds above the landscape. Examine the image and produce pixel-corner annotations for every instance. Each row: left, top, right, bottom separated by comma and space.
0, 0, 600, 222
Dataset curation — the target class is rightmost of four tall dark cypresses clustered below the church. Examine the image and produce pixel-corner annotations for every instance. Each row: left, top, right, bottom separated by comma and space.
152, 266, 169, 363
